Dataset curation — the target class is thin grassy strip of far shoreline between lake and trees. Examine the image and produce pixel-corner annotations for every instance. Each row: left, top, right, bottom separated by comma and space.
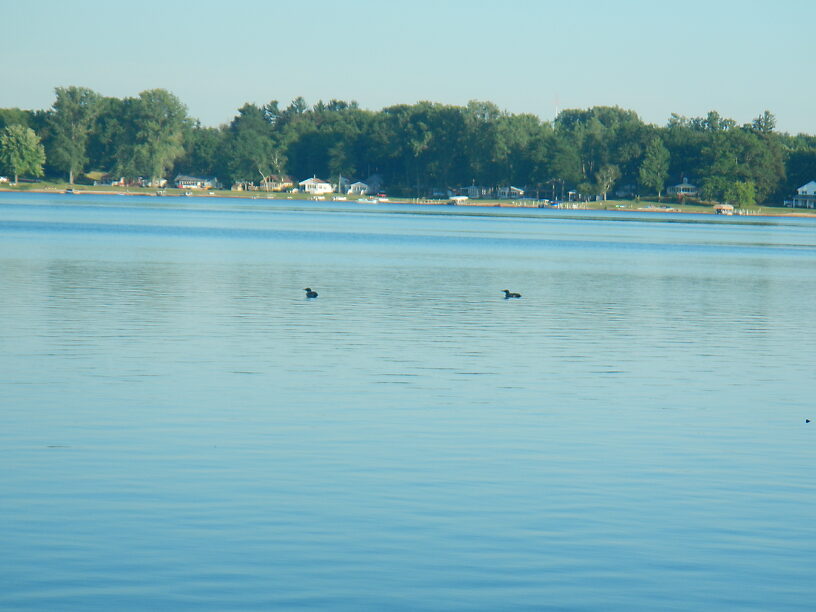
0, 186, 816, 218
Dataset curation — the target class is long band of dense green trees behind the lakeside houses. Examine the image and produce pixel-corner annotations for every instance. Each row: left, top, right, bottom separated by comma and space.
0, 87, 816, 205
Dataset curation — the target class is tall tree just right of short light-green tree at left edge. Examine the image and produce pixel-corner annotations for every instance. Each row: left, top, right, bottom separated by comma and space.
49, 87, 102, 184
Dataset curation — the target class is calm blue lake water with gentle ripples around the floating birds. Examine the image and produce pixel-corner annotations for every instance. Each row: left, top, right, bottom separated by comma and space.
0, 193, 816, 611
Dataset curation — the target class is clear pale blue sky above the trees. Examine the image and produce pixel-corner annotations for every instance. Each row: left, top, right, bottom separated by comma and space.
0, 0, 816, 134
